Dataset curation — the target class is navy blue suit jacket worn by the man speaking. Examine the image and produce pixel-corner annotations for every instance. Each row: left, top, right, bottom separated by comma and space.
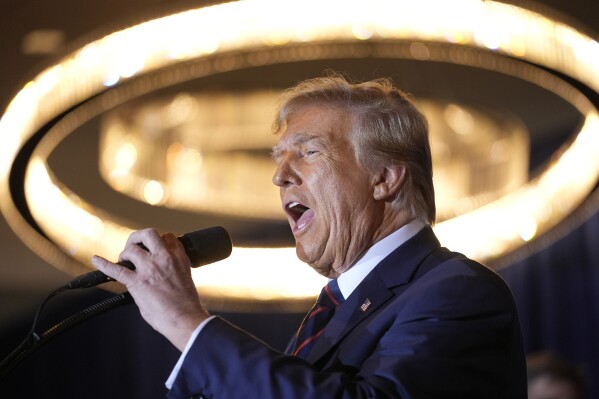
169, 227, 526, 399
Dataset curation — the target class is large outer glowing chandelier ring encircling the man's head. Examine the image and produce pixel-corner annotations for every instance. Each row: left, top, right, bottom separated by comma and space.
0, 0, 599, 310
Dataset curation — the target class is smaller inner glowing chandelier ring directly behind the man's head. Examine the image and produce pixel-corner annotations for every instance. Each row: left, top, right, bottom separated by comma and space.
99, 90, 529, 222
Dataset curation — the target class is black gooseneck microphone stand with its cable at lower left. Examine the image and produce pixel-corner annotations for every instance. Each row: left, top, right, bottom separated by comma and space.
0, 286, 133, 381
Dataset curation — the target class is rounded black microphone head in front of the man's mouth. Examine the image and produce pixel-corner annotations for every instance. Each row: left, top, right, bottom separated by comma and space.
179, 226, 233, 267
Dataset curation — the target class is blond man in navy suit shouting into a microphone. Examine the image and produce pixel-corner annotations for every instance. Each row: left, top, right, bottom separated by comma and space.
93, 77, 526, 399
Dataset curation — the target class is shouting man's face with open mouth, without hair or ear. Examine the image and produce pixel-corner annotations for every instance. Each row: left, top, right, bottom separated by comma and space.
273, 105, 384, 278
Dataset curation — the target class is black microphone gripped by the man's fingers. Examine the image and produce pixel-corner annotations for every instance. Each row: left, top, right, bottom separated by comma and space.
66, 226, 233, 289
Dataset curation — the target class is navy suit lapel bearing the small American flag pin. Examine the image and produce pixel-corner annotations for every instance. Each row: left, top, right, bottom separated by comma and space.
306, 227, 440, 364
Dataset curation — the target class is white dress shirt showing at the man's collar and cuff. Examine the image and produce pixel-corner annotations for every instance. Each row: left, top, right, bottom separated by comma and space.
165, 219, 425, 389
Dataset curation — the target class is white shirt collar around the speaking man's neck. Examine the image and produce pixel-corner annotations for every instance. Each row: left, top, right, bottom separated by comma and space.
337, 219, 426, 298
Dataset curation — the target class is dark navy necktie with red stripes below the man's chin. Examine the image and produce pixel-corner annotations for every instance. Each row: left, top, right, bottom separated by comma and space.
293, 280, 344, 358
